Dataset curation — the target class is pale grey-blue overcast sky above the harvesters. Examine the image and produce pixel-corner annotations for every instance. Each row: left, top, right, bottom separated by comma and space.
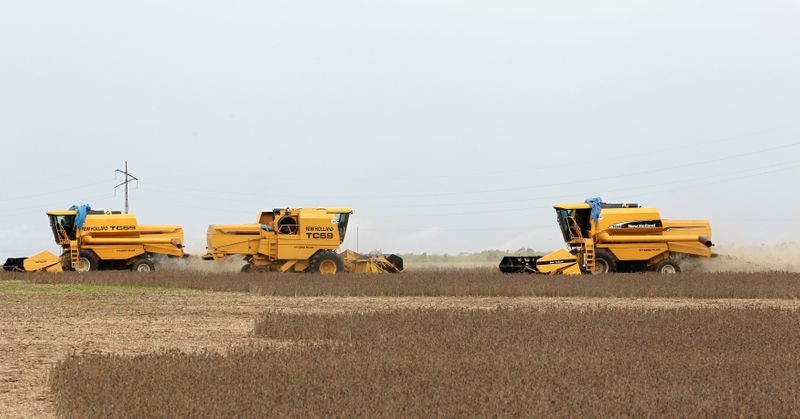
0, 0, 800, 260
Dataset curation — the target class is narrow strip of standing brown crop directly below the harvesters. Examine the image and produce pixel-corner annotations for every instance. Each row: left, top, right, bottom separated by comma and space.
9, 270, 800, 299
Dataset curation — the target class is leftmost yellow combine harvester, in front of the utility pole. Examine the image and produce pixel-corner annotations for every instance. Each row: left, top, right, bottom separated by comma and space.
4, 206, 183, 272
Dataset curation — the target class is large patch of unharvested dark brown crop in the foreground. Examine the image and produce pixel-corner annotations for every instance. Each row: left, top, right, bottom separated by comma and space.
51, 309, 800, 417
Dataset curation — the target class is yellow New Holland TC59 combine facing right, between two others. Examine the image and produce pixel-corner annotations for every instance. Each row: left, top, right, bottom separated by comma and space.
203, 208, 403, 274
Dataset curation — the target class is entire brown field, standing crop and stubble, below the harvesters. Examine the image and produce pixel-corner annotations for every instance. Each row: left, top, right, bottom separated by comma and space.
0, 271, 800, 417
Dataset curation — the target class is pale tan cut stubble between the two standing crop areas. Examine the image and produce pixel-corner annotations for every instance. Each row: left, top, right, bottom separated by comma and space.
0, 280, 800, 417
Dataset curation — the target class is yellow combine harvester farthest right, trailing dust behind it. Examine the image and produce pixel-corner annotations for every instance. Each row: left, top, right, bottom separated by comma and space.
500, 201, 713, 275
